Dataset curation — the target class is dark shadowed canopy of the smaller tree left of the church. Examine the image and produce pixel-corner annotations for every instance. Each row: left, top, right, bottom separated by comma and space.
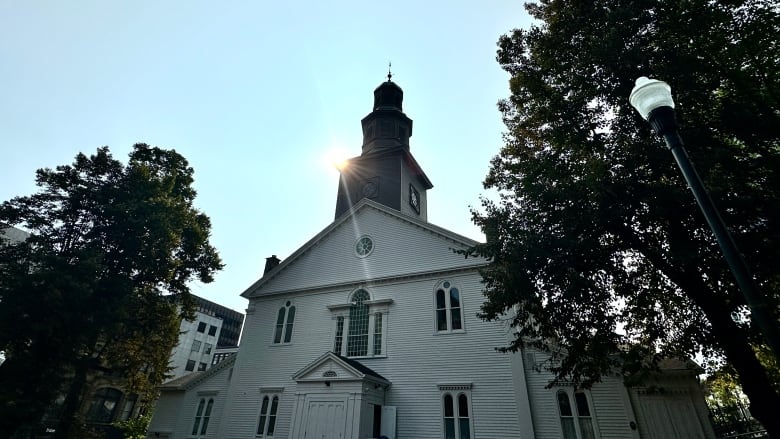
0, 144, 222, 437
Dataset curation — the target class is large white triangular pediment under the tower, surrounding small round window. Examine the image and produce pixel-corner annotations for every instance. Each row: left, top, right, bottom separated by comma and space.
241, 199, 486, 299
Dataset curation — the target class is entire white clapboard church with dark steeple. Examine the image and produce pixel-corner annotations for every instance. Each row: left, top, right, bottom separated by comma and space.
147, 78, 715, 439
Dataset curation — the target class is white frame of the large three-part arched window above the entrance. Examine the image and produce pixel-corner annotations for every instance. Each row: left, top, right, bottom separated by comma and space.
328, 287, 393, 358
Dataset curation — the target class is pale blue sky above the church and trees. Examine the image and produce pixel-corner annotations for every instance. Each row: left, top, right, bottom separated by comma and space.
0, 0, 530, 312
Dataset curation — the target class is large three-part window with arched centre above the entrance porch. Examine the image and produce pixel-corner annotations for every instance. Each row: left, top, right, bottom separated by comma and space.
329, 288, 392, 357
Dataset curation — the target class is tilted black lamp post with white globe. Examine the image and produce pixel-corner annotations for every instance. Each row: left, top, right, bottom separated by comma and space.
629, 76, 780, 362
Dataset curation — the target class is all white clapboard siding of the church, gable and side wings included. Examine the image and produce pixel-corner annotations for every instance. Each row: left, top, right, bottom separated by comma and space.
148, 201, 712, 439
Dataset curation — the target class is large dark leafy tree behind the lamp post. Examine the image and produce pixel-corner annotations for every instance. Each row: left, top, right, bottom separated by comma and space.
474, 0, 780, 437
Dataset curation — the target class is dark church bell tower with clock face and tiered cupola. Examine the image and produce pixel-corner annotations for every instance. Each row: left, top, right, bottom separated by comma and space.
336, 73, 433, 221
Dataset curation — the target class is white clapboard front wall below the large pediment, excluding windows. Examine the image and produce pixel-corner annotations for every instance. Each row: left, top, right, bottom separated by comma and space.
219, 272, 519, 438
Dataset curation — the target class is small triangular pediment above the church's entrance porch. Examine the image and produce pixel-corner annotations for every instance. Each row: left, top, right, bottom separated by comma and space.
292, 352, 390, 384
